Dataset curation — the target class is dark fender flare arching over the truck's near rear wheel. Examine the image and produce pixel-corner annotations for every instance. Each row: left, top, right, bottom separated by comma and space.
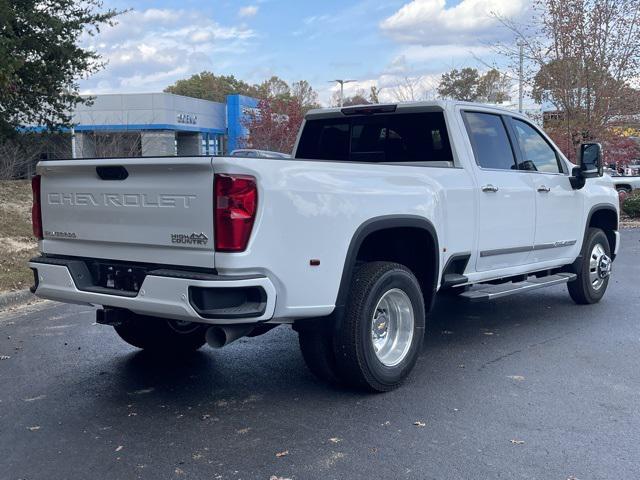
335, 215, 440, 313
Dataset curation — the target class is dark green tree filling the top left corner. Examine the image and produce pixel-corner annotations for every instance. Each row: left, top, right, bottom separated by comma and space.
0, 0, 122, 139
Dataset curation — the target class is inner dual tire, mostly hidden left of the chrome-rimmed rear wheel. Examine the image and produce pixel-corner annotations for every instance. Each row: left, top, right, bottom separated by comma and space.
298, 318, 341, 384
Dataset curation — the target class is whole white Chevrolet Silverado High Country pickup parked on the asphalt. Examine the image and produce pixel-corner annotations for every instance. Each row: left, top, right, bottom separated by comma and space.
30, 102, 620, 391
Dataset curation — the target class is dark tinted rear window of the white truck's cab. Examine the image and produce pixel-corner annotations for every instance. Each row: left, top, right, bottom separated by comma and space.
296, 112, 453, 165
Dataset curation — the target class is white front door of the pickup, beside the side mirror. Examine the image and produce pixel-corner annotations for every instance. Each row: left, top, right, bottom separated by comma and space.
510, 118, 584, 262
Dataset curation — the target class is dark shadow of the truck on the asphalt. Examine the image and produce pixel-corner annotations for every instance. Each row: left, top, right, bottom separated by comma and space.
104, 289, 606, 403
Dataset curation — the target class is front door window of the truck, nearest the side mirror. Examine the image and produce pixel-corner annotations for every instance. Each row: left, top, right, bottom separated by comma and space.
513, 118, 562, 173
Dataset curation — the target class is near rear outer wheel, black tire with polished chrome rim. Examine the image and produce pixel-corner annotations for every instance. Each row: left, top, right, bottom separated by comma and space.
334, 262, 425, 392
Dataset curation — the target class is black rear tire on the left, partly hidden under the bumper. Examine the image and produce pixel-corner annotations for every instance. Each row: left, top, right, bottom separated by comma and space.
114, 314, 206, 354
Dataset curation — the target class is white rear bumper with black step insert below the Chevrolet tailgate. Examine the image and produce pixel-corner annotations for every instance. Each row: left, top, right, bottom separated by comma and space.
29, 257, 276, 325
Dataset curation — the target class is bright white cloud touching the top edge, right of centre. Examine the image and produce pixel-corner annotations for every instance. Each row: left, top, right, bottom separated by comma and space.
380, 0, 530, 46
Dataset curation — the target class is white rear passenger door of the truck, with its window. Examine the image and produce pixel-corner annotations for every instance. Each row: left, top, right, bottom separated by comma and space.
462, 111, 536, 272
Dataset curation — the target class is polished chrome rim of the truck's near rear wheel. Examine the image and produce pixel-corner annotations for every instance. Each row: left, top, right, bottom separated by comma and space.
371, 288, 415, 367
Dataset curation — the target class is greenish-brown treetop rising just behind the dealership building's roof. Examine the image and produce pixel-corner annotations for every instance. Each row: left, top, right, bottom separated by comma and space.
164, 71, 258, 103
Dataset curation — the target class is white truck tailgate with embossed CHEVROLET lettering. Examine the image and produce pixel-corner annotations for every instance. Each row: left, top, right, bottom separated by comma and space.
38, 157, 214, 268
